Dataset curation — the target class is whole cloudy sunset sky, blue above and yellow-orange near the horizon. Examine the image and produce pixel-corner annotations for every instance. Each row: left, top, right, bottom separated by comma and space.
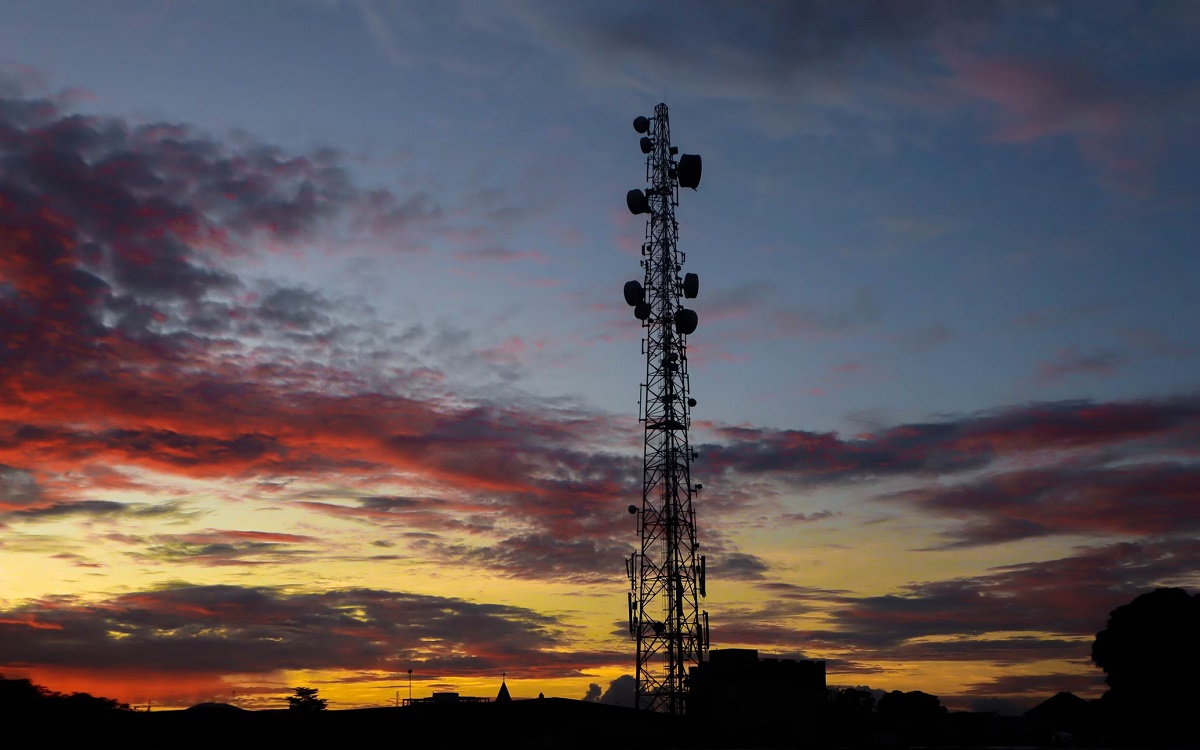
0, 0, 1200, 712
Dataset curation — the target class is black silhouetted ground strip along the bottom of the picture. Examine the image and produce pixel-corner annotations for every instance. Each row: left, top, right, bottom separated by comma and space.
11, 698, 1180, 750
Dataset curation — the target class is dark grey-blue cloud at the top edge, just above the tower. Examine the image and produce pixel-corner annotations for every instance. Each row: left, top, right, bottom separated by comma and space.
496, 0, 992, 104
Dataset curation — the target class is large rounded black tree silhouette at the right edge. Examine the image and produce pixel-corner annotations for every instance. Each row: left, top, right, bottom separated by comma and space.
1092, 588, 1200, 742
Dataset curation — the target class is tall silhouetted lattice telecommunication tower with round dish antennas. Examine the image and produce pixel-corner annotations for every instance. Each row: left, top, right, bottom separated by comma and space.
625, 104, 708, 714
